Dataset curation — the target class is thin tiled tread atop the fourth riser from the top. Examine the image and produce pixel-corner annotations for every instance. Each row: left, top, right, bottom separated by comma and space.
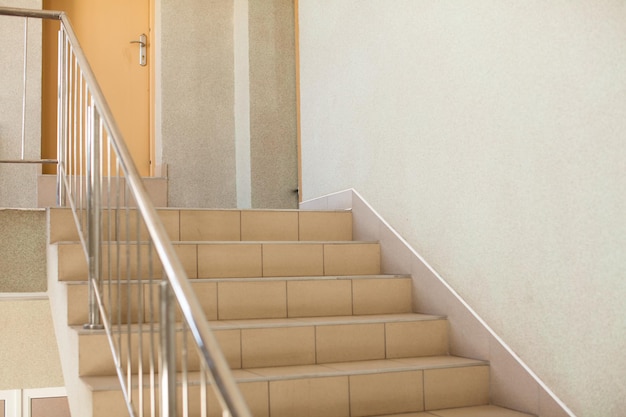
70, 313, 446, 335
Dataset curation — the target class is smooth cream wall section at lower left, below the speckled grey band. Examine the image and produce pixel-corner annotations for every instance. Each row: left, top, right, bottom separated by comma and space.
0, 298, 64, 390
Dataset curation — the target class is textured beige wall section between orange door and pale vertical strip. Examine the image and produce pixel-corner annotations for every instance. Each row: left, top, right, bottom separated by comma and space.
156, 0, 237, 207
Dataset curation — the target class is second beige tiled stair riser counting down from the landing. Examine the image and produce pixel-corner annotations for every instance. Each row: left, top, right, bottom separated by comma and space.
55, 241, 381, 281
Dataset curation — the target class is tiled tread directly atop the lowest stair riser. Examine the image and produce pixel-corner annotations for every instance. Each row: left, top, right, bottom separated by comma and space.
81, 355, 489, 391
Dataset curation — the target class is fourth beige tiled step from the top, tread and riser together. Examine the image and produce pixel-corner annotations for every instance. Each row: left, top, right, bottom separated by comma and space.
74, 314, 448, 376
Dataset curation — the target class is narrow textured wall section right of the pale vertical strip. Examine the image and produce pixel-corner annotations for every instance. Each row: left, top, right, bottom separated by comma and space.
249, 0, 298, 208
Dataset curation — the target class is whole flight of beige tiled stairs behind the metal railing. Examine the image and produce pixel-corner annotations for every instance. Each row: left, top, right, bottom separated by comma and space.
49, 209, 528, 417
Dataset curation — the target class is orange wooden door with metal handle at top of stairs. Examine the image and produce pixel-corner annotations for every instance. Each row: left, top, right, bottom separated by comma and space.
42, 0, 152, 176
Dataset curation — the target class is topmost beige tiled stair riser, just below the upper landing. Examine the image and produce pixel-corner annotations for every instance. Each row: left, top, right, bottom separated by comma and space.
50, 208, 352, 243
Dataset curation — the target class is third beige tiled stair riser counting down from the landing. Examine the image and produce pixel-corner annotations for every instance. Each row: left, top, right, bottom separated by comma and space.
66, 275, 413, 325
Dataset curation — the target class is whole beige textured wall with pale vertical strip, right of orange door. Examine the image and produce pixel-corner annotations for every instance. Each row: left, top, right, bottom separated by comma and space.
155, 0, 297, 207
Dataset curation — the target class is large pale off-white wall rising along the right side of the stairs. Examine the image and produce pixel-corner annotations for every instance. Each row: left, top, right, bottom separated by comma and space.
299, 0, 626, 417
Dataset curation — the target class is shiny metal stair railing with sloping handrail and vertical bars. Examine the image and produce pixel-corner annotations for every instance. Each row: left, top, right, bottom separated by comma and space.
0, 8, 251, 417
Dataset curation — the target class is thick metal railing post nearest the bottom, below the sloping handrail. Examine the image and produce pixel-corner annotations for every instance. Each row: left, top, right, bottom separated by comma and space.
159, 279, 176, 417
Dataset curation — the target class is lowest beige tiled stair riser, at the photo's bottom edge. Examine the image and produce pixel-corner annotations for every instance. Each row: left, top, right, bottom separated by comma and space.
93, 366, 489, 417
